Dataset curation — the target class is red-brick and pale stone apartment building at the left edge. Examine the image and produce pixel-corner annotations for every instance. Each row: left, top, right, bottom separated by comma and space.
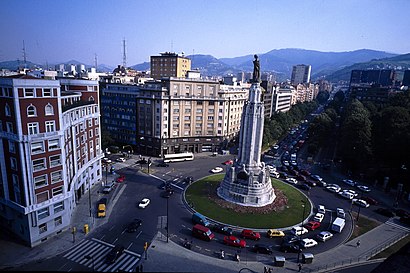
0, 75, 103, 246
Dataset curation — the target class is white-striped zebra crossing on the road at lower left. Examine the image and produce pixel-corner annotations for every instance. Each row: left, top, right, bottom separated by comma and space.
63, 238, 141, 272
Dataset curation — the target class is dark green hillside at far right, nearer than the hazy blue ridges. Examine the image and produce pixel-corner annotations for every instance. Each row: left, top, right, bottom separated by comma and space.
325, 53, 410, 82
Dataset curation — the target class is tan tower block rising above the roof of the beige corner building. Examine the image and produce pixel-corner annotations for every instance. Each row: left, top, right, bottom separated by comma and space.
151, 52, 191, 80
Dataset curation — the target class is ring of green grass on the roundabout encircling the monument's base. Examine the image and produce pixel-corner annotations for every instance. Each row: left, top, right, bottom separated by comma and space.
185, 174, 311, 229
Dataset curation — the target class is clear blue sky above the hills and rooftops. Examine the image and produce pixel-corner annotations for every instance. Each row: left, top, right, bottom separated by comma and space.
0, 0, 410, 66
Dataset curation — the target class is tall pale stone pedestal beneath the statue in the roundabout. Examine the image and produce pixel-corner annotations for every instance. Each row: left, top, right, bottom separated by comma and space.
217, 83, 276, 207
